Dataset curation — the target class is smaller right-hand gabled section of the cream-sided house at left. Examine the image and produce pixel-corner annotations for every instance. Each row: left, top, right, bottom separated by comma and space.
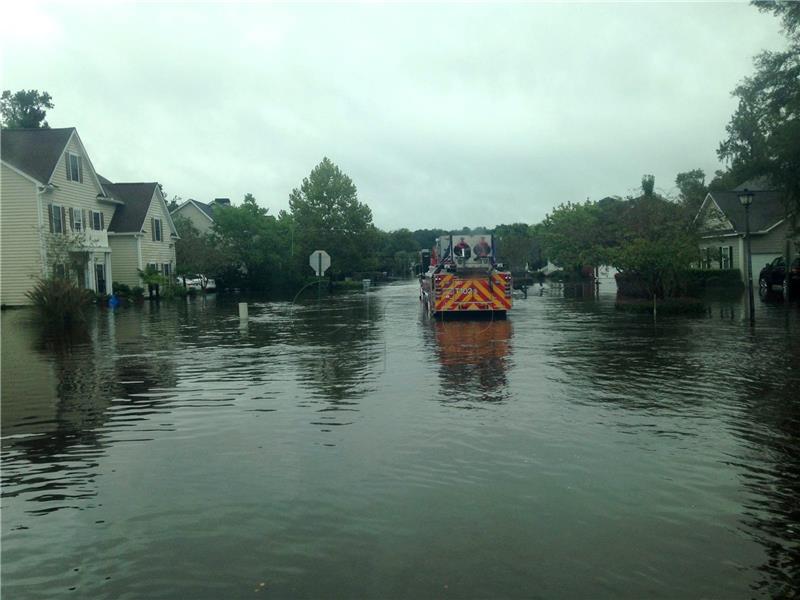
101, 177, 178, 286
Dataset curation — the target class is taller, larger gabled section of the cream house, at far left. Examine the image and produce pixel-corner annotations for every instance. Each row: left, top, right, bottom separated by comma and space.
0, 127, 121, 305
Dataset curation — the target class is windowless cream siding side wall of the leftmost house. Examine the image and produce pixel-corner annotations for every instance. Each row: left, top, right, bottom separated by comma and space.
0, 165, 42, 306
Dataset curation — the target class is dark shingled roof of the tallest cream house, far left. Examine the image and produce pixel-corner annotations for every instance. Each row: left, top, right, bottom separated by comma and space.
0, 127, 75, 184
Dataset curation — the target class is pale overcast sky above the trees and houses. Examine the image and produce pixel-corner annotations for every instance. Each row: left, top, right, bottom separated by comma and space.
0, 3, 784, 229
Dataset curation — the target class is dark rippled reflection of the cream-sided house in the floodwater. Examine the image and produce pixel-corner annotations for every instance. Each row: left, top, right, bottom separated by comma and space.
2, 311, 175, 514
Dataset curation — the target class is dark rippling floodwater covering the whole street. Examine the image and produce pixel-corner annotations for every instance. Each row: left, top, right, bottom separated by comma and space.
2, 282, 800, 599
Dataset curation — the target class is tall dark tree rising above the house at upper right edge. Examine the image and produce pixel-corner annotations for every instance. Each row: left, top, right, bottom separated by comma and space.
717, 0, 800, 209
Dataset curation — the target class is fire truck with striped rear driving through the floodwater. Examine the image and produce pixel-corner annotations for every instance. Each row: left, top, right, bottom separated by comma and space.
419, 234, 512, 319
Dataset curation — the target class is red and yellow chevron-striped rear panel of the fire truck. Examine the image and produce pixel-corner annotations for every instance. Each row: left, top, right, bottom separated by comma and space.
433, 273, 511, 311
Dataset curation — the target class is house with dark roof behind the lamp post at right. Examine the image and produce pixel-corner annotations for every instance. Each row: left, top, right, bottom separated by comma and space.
695, 179, 798, 280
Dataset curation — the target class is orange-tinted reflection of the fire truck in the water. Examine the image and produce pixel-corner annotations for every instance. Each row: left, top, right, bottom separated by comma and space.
429, 320, 513, 408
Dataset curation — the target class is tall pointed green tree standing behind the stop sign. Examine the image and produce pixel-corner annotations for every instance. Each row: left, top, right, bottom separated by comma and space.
289, 157, 378, 277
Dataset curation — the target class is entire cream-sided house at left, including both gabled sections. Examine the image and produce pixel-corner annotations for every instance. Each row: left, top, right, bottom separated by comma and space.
0, 127, 177, 305
